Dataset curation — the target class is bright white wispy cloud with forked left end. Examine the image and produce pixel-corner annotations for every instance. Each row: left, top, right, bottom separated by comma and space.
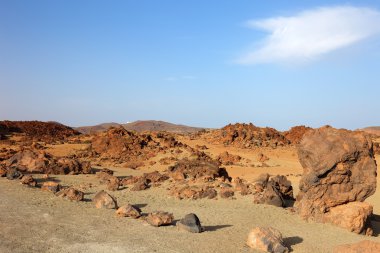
237, 6, 380, 64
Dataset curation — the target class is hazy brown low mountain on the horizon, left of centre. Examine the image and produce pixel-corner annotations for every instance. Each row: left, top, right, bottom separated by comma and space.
75, 120, 204, 133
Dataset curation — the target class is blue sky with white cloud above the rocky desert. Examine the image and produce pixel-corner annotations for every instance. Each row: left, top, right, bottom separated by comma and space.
0, 0, 380, 130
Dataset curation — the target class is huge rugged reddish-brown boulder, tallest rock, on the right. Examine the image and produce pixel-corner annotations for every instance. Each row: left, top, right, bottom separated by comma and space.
295, 127, 376, 233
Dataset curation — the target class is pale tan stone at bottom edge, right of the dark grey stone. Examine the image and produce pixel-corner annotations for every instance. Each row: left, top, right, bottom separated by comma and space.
247, 227, 289, 253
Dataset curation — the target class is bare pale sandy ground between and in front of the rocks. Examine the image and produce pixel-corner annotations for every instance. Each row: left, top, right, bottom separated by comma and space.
0, 139, 380, 253
